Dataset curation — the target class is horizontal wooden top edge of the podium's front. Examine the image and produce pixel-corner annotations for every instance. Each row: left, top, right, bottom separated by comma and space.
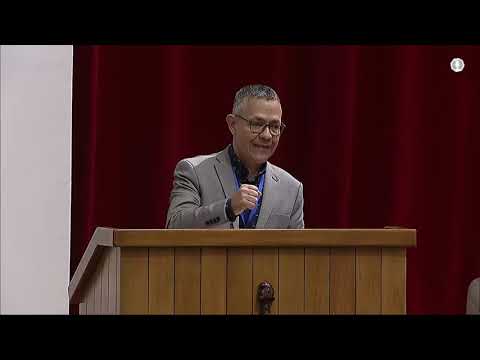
114, 229, 416, 247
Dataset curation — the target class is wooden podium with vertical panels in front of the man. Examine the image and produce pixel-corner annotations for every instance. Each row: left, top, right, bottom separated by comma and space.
68, 228, 416, 314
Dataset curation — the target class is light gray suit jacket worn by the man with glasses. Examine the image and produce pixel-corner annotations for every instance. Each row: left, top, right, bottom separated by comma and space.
166, 147, 304, 229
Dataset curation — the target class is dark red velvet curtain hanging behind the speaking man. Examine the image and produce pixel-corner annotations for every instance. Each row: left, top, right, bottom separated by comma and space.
71, 46, 480, 314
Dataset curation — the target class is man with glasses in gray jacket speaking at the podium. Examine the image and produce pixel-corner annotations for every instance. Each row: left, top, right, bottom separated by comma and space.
166, 85, 304, 229
